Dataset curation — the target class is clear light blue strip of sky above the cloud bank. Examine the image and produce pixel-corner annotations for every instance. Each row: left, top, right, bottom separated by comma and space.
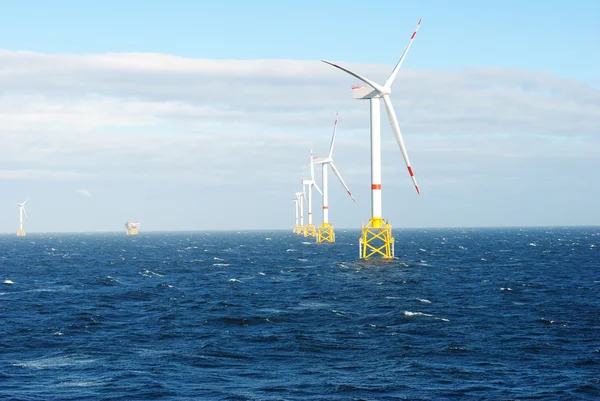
0, 0, 600, 84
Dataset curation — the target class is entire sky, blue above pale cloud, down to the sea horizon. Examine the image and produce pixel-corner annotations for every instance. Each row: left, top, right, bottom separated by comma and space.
0, 0, 600, 233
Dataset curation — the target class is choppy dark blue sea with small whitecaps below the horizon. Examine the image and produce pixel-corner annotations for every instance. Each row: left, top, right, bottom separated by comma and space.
0, 227, 600, 400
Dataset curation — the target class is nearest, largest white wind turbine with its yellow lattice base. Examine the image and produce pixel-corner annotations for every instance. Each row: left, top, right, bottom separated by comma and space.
322, 20, 421, 259
